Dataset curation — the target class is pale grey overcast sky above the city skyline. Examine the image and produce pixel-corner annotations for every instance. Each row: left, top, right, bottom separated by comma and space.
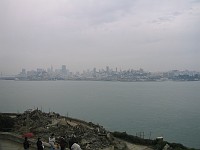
0, 0, 200, 73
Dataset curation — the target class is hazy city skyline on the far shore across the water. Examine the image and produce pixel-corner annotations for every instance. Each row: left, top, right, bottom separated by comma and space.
12, 65, 200, 82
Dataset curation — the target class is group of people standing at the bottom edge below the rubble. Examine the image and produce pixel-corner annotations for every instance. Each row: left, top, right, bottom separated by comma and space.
23, 134, 81, 150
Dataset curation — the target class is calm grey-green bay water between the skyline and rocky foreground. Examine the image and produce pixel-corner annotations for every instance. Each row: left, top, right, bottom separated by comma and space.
0, 80, 200, 148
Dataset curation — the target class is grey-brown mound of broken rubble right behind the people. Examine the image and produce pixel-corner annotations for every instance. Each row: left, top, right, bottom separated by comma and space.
14, 109, 112, 150
